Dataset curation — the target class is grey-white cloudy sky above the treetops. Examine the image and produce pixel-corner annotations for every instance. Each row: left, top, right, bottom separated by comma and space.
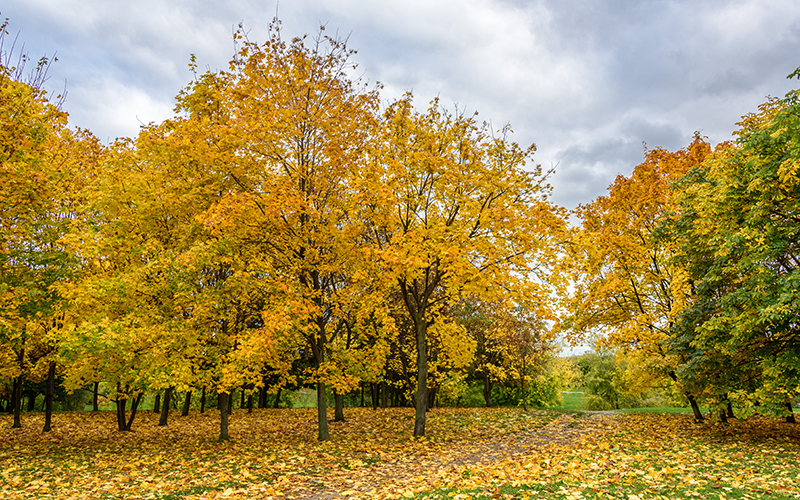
0, 0, 800, 208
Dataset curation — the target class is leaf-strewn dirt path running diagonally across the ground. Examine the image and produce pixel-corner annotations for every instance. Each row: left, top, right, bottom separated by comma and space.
217, 412, 619, 500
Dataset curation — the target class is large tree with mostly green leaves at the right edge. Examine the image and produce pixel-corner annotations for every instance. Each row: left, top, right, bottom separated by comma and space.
669, 70, 800, 417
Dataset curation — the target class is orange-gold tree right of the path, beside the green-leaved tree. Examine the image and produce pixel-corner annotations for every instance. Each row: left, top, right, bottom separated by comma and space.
565, 135, 711, 419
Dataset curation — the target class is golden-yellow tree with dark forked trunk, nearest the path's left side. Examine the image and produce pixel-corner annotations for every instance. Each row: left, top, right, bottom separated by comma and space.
371, 96, 563, 436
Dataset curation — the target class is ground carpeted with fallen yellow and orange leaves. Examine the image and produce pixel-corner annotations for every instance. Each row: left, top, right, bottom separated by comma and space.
0, 408, 800, 500
